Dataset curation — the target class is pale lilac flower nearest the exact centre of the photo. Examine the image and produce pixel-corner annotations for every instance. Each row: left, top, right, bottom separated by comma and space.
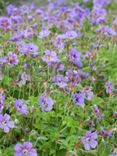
54, 75, 67, 88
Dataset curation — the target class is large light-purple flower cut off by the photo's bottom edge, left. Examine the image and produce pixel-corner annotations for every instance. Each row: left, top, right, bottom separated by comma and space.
14, 142, 37, 156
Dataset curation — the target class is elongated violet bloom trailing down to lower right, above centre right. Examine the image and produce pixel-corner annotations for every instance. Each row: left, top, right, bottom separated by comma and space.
69, 49, 82, 68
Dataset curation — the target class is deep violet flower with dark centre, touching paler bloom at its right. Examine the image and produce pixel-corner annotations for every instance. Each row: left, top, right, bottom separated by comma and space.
73, 93, 84, 106
